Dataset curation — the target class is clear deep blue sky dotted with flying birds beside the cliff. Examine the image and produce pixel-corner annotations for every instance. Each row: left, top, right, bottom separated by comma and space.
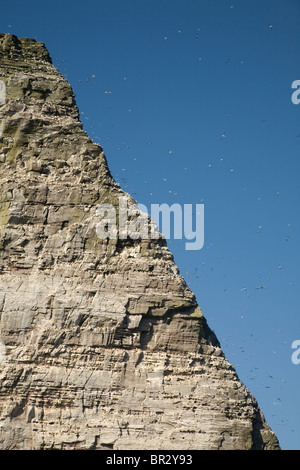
0, 0, 300, 449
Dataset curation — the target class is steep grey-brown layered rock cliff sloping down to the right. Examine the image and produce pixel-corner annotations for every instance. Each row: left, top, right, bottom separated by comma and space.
0, 34, 279, 450
